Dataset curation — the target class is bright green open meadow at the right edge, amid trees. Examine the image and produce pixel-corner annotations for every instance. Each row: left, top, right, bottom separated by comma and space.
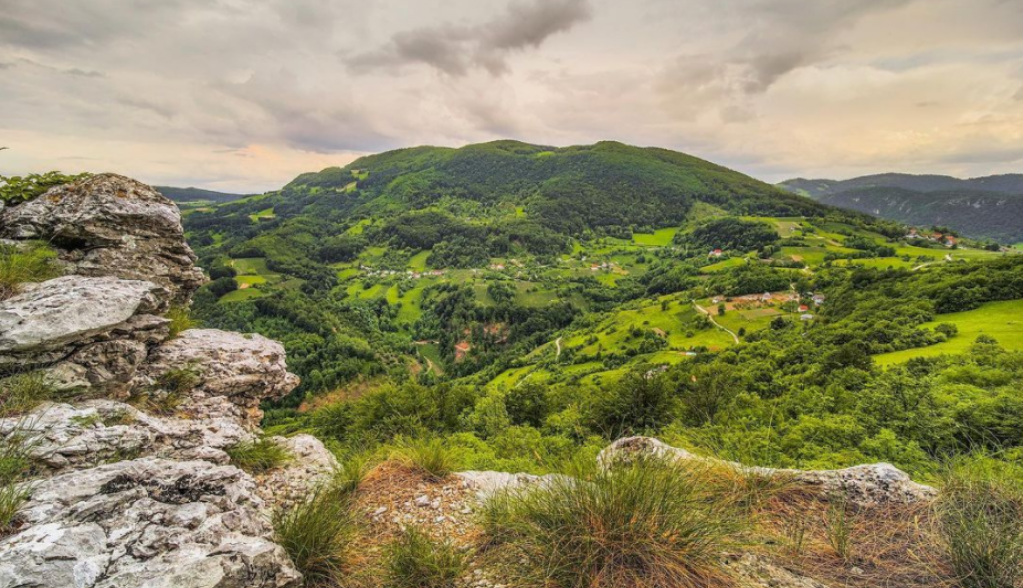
874, 300, 1023, 365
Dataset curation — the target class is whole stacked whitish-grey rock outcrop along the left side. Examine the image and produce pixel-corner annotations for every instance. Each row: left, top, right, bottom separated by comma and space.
0, 174, 319, 588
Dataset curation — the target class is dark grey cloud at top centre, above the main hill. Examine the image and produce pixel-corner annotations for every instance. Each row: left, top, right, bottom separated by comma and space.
343, 0, 592, 76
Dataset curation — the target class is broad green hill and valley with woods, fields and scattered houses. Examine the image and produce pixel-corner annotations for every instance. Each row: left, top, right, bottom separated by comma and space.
185, 141, 1023, 474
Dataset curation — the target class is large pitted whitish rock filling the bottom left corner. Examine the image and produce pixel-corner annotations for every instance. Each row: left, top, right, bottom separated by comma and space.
0, 458, 301, 588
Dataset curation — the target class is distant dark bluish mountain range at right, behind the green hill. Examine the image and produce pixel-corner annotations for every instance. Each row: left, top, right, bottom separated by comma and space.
779, 174, 1023, 243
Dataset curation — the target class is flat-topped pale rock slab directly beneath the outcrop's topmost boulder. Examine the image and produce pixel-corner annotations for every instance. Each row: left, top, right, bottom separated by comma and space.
0, 276, 168, 396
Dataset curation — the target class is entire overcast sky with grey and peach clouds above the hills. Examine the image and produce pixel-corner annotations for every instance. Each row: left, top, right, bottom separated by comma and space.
0, 0, 1023, 191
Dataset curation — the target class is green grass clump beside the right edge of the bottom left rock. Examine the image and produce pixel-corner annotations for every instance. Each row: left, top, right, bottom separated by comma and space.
271, 480, 357, 588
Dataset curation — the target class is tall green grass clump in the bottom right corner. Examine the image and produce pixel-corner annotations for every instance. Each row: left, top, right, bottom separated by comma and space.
935, 457, 1023, 588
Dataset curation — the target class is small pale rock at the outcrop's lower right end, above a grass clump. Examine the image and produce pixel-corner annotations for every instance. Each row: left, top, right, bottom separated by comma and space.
258, 435, 338, 504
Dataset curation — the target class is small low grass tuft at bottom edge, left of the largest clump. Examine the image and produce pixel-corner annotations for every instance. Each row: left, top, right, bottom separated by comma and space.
385, 527, 465, 588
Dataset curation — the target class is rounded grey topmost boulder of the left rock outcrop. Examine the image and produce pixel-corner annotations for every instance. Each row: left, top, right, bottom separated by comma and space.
0, 174, 205, 303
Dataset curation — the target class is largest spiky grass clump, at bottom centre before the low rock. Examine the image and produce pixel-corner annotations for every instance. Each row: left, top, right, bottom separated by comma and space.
474, 460, 747, 588
